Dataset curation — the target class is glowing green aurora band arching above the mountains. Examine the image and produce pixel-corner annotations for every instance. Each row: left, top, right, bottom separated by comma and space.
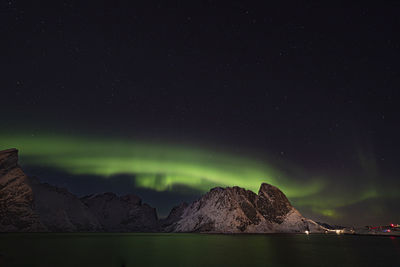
0, 134, 394, 222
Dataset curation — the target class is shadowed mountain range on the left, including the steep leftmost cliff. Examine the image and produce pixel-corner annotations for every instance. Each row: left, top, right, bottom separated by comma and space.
0, 149, 158, 232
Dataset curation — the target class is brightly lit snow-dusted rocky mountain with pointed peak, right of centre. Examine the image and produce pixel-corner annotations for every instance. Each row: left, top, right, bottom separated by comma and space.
163, 183, 326, 233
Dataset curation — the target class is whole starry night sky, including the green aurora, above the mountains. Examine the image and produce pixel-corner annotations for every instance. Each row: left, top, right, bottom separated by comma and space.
0, 0, 400, 225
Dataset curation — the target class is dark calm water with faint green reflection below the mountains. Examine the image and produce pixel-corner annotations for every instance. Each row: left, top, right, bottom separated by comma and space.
0, 233, 400, 267
